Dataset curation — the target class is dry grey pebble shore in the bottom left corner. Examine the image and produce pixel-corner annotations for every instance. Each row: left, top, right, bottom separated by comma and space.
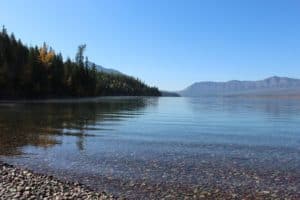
0, 162, 116, 200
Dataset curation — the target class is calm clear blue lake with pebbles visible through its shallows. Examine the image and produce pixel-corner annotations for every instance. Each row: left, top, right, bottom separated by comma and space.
0, 97, 300, 199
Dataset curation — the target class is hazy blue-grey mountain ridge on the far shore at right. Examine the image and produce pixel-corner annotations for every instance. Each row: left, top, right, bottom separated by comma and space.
178, 76, 300, 96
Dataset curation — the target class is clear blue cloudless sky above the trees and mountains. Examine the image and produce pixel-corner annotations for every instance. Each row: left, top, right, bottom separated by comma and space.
0, 0, 300, 90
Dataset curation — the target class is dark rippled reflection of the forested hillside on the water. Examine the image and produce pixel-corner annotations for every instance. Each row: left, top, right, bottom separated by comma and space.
0, 98, 157, 155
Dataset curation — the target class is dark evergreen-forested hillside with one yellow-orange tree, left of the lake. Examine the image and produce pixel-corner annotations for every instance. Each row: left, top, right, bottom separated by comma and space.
0, 27, 161, 99
